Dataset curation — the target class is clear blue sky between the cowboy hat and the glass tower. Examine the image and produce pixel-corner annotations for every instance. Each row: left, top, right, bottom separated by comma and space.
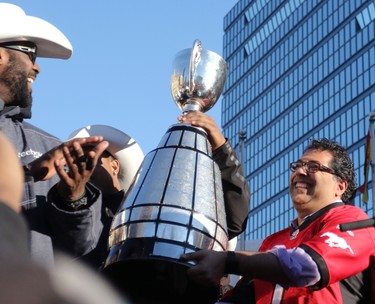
9, 0, 237, 154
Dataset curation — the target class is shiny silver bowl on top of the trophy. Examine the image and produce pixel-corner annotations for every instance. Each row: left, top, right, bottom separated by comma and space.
171, 40, 227, 112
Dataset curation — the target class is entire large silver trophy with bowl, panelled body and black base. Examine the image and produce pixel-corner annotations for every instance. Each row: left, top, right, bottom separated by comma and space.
103, 40, 228, 303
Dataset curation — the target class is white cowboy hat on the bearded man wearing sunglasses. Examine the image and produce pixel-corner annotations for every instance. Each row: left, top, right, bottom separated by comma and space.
0, 3, 73, 59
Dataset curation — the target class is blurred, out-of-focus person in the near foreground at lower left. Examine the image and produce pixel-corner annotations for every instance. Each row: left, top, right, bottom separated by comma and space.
0, 132, 128, 304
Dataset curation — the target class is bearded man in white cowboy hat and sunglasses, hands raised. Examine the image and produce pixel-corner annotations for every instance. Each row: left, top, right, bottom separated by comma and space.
0, 3, 105, 265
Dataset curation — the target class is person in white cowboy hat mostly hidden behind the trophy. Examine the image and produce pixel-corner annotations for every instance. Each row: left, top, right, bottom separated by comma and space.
49, 111, 250, 301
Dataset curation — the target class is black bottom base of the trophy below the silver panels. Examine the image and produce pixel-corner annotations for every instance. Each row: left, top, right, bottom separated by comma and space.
102, 242, 220, 304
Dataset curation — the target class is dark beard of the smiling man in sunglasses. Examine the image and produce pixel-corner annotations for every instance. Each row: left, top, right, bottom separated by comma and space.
0, 53, 32, 109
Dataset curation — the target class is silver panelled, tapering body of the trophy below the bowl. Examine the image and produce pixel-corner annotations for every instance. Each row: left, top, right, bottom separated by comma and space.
109, 124, 228, 259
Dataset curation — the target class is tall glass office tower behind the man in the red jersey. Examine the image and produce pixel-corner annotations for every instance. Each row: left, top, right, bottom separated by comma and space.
222, 0, 375, 240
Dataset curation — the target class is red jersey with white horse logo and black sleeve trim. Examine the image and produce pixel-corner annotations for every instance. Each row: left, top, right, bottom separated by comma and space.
254, 203, 375, 304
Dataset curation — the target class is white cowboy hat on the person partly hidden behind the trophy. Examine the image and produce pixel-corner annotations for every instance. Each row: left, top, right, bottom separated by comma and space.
69, 125, 144, 192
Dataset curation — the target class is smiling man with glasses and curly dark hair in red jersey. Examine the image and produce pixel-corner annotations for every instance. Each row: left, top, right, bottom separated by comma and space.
181, 139, 375, 304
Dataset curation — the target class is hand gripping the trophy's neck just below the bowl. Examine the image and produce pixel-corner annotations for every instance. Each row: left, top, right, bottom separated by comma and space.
177, 111, 226, 151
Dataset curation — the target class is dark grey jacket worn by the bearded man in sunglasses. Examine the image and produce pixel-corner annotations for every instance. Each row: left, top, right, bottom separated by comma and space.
0, 100, 102, 265
